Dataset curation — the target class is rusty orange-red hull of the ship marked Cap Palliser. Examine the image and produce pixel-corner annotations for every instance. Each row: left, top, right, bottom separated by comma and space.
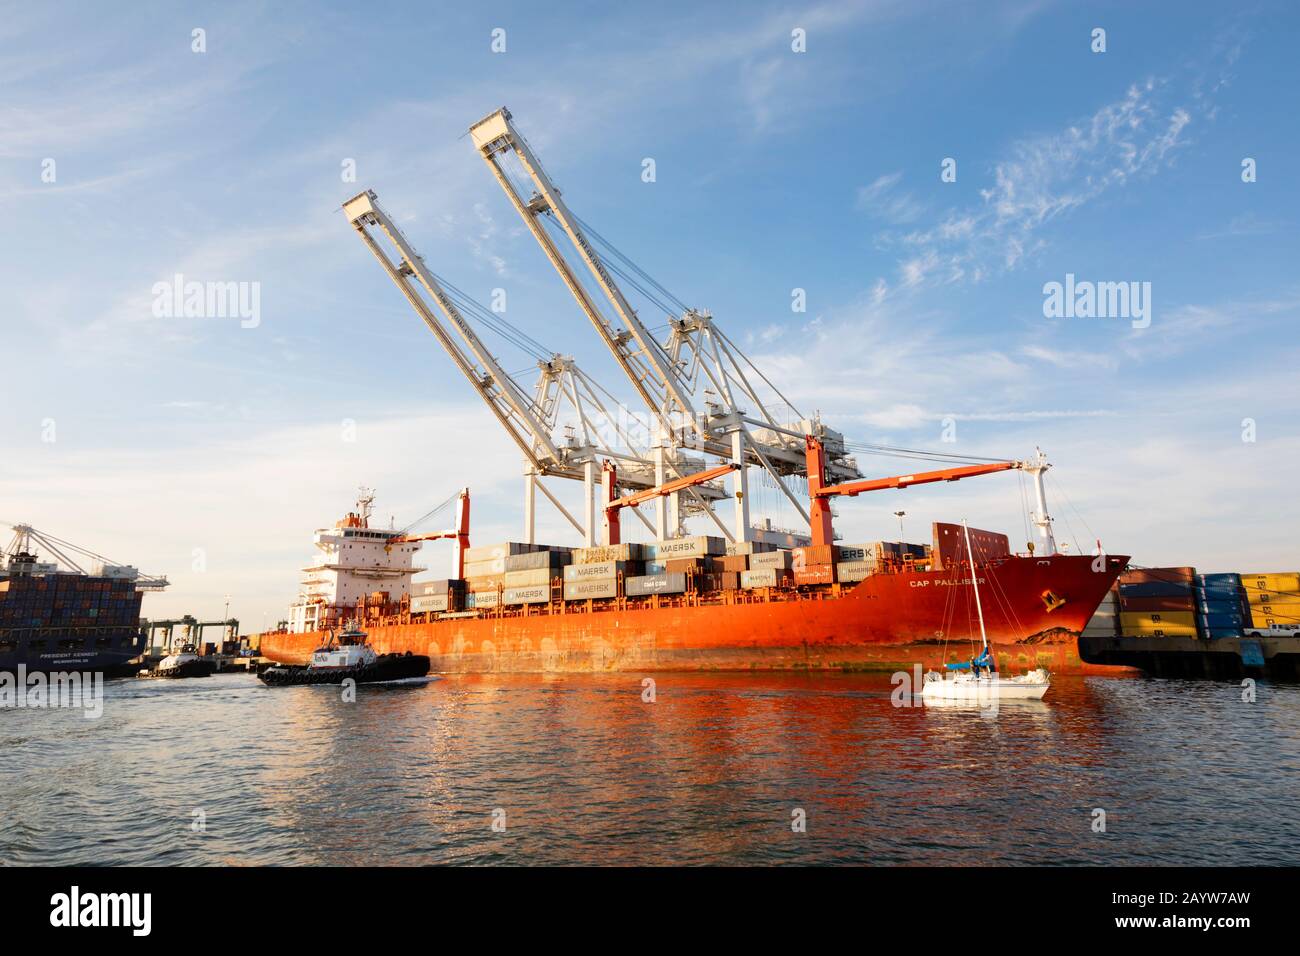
260, 555, 1127, 674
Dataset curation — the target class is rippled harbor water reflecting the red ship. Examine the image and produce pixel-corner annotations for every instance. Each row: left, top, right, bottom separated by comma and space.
0, 674, 1300, 865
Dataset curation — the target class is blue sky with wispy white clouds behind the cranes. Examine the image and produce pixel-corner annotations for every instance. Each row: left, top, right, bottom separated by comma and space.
0, 1, 1300, 628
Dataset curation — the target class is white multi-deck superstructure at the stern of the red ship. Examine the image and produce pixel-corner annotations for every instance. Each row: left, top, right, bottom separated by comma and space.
289, 489, 425, 633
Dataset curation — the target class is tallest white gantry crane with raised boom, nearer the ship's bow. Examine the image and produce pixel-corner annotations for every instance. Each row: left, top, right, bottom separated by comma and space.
469, 108, 861, 541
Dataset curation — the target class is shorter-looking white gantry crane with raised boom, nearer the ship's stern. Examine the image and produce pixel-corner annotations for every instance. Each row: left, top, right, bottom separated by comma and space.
343, 190, 725, 545
